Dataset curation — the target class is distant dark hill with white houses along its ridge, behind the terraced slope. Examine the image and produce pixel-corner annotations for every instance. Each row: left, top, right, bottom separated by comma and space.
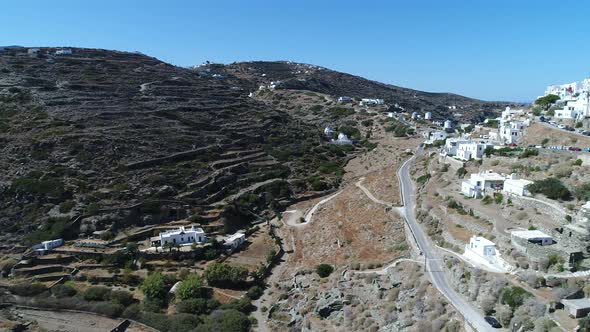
195, 61, 514, 121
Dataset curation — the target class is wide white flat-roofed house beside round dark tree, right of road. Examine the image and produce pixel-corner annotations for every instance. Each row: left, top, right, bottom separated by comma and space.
461, 170, 533, 198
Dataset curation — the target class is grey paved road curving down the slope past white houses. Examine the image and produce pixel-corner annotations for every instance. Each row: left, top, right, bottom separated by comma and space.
397, 152, 495, 332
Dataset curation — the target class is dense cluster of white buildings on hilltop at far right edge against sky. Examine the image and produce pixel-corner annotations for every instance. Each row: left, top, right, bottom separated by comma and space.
543, 78, 590, 119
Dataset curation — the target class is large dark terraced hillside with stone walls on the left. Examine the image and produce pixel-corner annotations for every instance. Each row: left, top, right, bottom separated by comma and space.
0, 48, 353, 244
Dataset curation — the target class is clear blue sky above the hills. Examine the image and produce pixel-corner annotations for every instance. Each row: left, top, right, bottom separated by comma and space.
0, 0, 590, 101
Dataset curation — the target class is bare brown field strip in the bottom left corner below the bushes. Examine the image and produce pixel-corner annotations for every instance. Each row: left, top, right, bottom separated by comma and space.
15, 308, 154, 332
